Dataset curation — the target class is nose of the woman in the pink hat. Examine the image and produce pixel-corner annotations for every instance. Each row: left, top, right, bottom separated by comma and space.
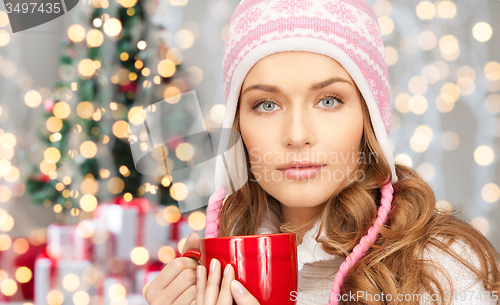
282, 106, 316, 148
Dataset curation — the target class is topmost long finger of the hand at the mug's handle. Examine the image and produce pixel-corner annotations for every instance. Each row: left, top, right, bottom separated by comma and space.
146, 257, 199, 297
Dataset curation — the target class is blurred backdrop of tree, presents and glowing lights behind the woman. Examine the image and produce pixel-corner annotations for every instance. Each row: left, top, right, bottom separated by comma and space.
0, 0, 500, 305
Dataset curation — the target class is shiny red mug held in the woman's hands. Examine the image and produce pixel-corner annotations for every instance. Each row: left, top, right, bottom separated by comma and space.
182, 233, 298, 305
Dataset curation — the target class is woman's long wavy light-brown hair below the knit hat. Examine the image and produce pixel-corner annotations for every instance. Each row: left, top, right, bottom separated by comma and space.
219, 93, 500, 304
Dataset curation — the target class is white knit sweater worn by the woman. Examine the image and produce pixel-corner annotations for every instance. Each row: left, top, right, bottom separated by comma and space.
257, 213, 500, 305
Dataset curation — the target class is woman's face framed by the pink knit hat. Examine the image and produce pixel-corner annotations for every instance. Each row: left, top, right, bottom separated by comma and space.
239, 52, 363, 208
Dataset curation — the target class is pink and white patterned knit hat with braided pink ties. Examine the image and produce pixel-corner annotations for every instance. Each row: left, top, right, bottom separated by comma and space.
205, 0, 398, 304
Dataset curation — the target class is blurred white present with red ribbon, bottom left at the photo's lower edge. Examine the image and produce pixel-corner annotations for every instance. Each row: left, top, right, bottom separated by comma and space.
34, 247, 96, 305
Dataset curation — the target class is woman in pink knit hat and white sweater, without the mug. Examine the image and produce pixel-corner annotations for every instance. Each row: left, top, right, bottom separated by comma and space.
146, 0, 500, 305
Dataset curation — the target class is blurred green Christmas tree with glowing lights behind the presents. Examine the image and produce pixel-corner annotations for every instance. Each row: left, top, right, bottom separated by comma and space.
26, 0, 192, 216
